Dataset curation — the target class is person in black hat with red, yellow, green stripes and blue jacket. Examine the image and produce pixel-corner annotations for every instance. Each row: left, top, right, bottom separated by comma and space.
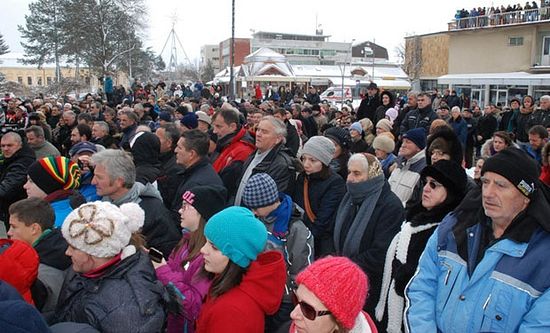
23, 156, 86, 228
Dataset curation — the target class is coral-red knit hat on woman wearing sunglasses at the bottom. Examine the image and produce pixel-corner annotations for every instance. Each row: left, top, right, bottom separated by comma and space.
296, 257, 369, 329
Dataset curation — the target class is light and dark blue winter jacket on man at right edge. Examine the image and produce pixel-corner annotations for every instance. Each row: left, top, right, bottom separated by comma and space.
405, 209, 550, 333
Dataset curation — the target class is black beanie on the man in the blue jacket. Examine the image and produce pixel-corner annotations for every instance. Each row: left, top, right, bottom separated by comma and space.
481, 147, 540, 198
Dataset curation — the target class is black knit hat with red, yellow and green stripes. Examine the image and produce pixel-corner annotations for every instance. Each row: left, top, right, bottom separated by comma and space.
28, 156, 80, 194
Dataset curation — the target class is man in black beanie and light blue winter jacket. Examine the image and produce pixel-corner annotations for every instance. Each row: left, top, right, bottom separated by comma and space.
405, 148, 550, 332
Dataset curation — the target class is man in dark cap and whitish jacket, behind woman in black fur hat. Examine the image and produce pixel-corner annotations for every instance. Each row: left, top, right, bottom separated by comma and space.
388, 127, 426, 206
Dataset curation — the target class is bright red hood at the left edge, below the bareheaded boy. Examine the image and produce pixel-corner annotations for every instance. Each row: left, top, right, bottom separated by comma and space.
0, 239, 39, 304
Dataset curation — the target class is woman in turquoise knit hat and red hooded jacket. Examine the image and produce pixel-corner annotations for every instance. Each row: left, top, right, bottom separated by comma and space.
196, 206, 286, 333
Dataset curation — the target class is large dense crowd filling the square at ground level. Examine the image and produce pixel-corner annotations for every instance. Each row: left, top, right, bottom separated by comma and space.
0, 79, 550, 332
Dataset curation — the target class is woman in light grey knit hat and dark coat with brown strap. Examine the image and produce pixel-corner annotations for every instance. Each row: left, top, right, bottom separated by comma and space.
293, 136, 346, 258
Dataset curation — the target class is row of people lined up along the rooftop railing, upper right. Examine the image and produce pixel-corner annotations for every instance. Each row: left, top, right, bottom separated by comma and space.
455, 0, 550, 29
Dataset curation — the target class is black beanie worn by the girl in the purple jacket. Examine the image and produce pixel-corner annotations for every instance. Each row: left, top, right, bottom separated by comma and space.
182, 185, 227, 221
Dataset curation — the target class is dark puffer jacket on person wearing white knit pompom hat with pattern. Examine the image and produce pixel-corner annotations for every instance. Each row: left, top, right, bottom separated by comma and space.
54, 251, 166, 333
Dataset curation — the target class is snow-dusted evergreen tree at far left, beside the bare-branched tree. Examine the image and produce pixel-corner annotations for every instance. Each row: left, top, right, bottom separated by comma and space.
18, 0, 64, 81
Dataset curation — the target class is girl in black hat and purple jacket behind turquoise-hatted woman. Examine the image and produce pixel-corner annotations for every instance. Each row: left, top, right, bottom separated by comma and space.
157, 186, 227, 333
